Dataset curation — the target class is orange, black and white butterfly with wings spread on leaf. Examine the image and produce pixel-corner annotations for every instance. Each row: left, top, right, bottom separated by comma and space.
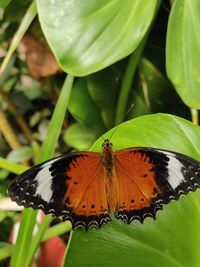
8, 139, 200, 230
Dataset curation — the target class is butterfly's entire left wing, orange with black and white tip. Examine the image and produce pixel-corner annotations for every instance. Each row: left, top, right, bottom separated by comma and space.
8, 152, 110, 228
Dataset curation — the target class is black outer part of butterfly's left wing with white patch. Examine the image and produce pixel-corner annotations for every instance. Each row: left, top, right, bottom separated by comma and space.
8, 153, 80, 219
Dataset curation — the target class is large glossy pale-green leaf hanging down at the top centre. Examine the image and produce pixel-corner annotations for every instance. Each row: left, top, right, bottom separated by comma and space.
37, 0, 160, 76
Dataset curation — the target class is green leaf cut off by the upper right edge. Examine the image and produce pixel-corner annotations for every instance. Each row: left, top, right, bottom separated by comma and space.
167, 0, 200, 109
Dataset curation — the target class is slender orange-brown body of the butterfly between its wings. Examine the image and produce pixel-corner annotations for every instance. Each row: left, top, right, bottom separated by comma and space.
101, 140, 118, 211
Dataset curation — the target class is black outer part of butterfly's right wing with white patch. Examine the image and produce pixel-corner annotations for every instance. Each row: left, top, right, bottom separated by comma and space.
141, 148, 200, 205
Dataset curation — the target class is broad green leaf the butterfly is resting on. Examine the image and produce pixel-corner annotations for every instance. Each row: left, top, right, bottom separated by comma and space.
64, 114, 200, 267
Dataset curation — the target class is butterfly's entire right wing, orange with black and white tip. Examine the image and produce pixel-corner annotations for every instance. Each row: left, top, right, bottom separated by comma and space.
115, 148, 200, 223
